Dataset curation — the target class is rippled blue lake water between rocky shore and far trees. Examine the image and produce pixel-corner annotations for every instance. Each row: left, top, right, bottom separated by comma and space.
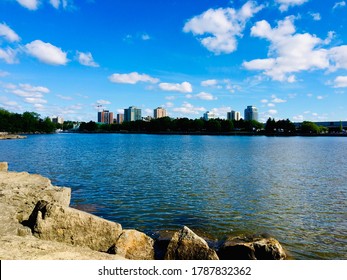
0, 134, 347, 259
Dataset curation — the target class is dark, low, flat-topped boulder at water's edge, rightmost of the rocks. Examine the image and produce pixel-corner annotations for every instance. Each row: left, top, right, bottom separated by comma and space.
218, 236, 287, 260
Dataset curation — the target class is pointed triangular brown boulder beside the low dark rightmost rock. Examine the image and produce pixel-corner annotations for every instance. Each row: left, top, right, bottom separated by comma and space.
164, 226, 218, 260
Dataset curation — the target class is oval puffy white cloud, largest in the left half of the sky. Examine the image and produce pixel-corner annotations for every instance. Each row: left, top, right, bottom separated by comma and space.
25, 40, 68, 65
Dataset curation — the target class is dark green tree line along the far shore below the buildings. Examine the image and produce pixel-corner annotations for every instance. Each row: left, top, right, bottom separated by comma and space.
0, 108, 328, 135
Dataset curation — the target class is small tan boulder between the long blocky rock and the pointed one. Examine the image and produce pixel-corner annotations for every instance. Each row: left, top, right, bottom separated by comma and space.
108, 230, 154, 260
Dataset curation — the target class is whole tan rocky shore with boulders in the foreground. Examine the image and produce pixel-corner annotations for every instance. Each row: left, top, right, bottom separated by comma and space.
0, 162, 287, 260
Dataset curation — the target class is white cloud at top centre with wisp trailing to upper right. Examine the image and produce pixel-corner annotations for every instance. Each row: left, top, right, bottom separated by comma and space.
183, 1, 263, 54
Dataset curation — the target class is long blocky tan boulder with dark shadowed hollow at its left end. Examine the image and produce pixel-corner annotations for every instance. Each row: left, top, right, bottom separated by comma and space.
27, 200, 122, 252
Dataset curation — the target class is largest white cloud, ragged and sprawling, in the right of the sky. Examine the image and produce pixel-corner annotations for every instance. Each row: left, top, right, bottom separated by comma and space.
243, 16, 329, 83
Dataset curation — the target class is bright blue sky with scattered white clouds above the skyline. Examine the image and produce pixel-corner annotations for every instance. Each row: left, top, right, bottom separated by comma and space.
0, 0, 347, 122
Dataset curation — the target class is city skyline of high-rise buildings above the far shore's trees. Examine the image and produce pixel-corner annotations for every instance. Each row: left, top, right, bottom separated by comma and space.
98, 106, 258, 124
